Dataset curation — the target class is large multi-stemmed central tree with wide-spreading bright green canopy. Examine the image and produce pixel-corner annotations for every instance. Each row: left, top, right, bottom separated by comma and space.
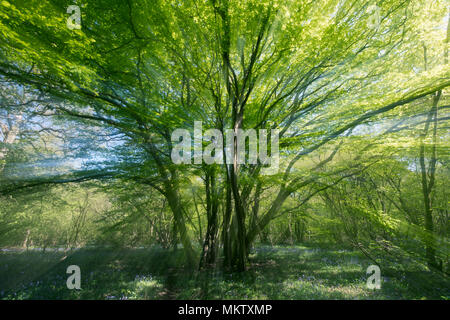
0, 0, 450, 270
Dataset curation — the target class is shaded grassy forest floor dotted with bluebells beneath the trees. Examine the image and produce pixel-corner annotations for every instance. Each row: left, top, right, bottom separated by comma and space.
0, 246, 450, 299
